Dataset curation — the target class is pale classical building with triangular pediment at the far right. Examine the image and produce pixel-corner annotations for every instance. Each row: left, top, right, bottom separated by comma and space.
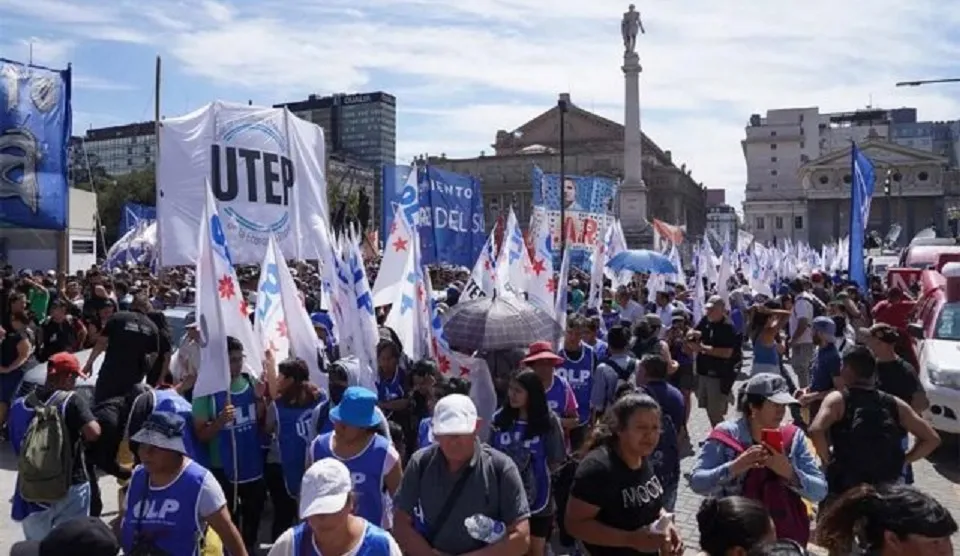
804, 134, 958, 246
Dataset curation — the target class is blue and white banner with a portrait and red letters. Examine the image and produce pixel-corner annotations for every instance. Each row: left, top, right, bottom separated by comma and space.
533, 167, 618, 268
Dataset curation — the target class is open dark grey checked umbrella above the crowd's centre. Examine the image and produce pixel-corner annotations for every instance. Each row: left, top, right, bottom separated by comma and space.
443, 296, 563, 352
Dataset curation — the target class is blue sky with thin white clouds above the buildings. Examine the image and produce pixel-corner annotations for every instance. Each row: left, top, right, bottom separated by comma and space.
0, 0, 960, 215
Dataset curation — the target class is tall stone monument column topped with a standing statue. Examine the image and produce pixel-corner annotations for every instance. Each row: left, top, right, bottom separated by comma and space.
620, 4, 653, 248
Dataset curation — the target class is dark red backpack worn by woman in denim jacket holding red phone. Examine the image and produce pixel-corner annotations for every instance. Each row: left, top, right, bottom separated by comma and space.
707, 424, 810, 546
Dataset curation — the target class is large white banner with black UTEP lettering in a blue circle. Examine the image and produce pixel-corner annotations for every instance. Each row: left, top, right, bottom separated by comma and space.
157, 101, 330, 266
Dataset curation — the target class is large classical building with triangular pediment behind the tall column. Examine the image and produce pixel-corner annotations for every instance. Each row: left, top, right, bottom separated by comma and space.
429, 95, 706, 246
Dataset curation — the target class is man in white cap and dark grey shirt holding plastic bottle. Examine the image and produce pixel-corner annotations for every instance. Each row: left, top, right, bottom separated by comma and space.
393, 394, 530, 556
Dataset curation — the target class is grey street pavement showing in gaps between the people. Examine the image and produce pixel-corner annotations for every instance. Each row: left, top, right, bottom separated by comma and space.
0, 354, 960, 556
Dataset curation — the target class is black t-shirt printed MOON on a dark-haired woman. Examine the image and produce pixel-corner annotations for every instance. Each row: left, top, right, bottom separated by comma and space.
570, 446, 663, 556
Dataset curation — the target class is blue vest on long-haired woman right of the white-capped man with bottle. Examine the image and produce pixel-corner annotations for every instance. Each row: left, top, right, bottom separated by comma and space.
490, 412, 550, 514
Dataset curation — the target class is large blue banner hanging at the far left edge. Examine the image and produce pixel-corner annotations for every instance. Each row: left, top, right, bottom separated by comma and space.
0, 58, 72, 230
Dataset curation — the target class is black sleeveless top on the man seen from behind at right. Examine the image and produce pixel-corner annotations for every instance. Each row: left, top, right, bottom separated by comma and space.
827, 388, 906, 493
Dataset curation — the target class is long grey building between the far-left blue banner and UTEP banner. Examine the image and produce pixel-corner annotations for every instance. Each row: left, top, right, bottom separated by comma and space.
70, 122, 157, 176
